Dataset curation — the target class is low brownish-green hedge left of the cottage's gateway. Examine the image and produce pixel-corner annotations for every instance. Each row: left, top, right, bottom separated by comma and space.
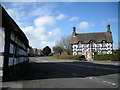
53, 55, 85, 60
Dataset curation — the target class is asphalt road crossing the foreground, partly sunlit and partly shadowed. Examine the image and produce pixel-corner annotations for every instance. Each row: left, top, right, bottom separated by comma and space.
4, 57, 119, 88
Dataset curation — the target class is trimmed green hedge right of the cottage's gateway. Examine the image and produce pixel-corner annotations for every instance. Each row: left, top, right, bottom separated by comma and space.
94, 54, 119, 61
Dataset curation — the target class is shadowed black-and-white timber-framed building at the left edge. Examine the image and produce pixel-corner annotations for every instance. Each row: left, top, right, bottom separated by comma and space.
0, 5, 30, 81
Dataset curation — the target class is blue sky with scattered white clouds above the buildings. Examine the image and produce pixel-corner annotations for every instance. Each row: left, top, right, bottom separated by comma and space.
2, 2, 118, 49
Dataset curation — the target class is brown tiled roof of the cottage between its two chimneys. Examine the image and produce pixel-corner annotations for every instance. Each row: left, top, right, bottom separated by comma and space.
71, 32, 113, 44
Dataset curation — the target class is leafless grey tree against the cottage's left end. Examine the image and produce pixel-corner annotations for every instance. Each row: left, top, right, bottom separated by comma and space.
56, 35, 72, 53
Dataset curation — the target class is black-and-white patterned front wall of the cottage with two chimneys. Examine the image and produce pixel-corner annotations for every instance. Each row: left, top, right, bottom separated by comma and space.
72, 43, 112, 55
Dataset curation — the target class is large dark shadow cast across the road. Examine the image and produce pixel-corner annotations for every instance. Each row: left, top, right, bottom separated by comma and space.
14, 62, 119, 80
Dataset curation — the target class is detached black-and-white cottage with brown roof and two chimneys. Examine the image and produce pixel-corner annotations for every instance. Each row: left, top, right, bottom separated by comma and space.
71, 24, 113, 55
